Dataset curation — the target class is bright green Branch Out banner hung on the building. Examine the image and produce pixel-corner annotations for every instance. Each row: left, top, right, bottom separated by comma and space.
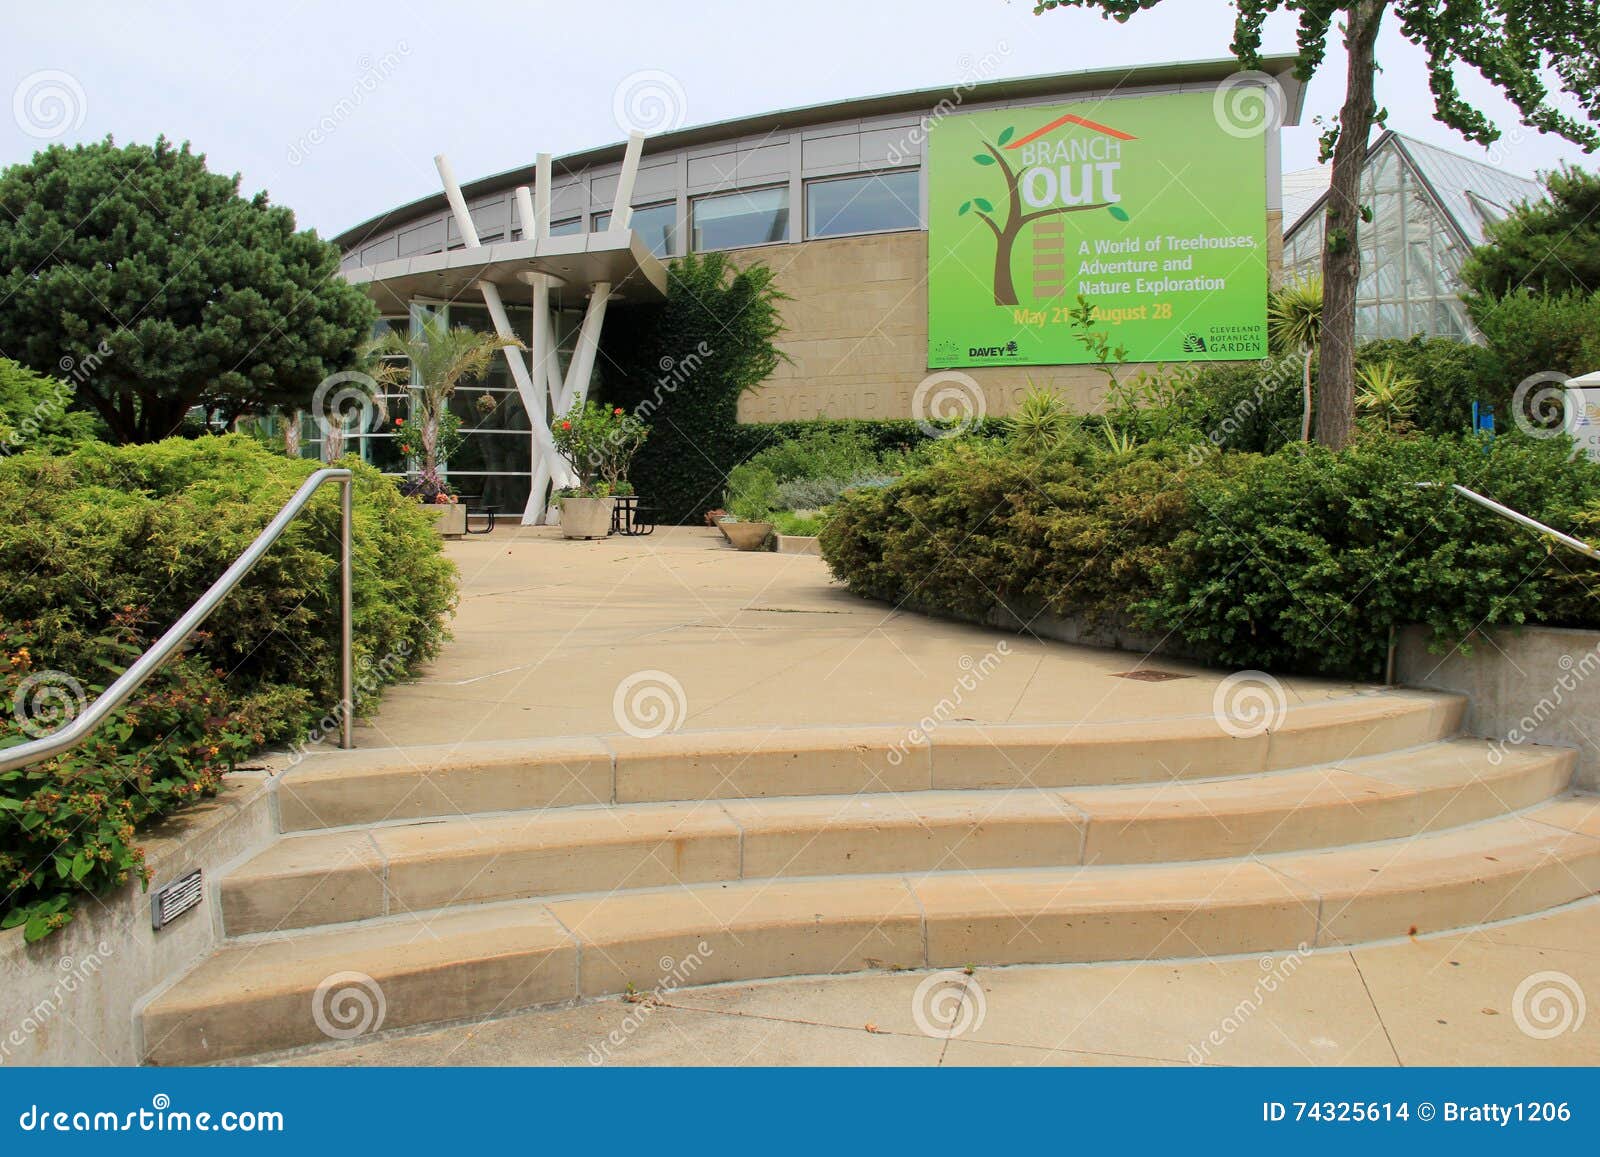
928, 93, 1267, 366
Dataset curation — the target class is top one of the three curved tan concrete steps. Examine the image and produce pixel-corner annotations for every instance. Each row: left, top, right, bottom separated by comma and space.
275, 690, 1466, 832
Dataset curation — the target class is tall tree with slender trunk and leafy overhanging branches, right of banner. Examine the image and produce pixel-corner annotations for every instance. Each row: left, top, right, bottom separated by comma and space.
1034, 0, 1600, 450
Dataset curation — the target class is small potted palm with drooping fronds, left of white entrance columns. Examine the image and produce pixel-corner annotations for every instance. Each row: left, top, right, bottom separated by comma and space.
368, 314, 522, 538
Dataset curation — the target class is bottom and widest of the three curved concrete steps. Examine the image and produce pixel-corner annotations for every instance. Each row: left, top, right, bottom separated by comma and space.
141, 797, 1600, 1064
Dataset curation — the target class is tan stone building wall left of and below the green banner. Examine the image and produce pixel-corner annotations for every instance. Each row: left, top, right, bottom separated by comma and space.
728, 211, 1283, 422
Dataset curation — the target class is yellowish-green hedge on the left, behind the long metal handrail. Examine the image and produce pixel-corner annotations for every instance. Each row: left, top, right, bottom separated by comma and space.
0, 435, 454, 938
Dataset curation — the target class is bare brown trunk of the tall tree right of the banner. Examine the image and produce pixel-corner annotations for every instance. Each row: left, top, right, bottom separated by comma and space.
1317, 0, 1389, 450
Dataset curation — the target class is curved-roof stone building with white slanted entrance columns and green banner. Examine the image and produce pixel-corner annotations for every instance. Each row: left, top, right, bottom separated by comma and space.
334, 58, 1304, 521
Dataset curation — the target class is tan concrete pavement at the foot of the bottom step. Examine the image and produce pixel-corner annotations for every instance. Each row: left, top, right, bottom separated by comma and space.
288, 899, 1600, 1066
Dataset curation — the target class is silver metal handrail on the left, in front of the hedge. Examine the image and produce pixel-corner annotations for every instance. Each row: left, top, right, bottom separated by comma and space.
0, 467, 354, 771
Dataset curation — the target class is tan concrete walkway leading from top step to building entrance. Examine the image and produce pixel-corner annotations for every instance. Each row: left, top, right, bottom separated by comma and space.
357, 526, 1382, 747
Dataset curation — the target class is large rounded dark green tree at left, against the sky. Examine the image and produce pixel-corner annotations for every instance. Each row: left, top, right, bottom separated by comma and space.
0, 138, 376, 442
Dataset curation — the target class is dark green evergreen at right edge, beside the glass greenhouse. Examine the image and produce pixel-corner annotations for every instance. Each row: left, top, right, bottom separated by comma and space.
1461, 165, 1600, 296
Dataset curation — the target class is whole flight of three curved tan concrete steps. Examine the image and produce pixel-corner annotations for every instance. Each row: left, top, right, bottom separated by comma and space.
141, 690, 1600, 1064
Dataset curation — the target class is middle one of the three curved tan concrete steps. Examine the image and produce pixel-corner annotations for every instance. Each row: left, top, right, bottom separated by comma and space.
221, 739, 1574, 936
